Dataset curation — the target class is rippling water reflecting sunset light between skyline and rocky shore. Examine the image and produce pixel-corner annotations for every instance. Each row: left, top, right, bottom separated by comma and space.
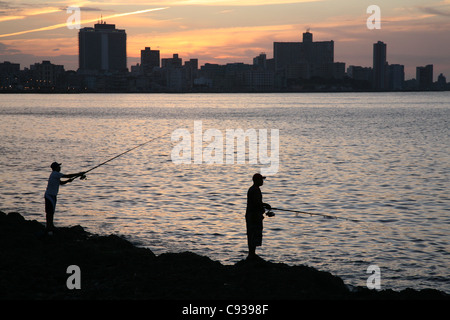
0, 92, 450, 293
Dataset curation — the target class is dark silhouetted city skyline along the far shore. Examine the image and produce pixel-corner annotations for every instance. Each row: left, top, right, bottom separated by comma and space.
0, 27, 442, 93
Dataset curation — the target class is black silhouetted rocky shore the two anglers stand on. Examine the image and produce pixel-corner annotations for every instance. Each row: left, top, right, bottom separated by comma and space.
0, 211, 450, 301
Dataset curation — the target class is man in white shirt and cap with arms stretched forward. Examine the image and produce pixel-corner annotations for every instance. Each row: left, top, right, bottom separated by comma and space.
44, 162, 84, 233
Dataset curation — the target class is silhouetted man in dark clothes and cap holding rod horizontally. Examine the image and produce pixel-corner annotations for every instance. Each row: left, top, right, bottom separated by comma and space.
245, 173, 271, 259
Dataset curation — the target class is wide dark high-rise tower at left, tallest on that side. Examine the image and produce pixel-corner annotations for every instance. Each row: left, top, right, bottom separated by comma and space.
78, 21, 127, 73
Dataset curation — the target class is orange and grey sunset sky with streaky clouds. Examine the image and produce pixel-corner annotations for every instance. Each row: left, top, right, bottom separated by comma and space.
0, 0, 450, 81
